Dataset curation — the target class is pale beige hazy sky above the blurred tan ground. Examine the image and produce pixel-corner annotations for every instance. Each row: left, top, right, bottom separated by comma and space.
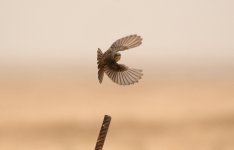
0, 0, 234, 78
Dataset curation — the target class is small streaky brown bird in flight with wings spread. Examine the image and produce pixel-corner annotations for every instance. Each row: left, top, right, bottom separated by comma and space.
97, 34, 143, 85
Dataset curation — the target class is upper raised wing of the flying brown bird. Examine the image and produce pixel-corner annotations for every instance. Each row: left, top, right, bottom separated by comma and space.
108, 34, 142, 51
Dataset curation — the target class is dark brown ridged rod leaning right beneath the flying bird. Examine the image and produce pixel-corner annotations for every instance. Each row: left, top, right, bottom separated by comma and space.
95, 115, 111, 150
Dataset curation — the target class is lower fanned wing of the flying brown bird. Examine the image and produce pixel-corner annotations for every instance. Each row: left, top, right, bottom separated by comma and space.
104, 63, 143, 85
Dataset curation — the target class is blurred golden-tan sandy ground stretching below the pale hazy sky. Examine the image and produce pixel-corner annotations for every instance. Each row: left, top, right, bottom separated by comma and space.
0, 75, 234, 150
